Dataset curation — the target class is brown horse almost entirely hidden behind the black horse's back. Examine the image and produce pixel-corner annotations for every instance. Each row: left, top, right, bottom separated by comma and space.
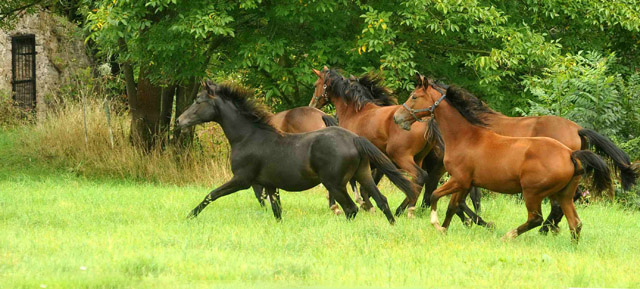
251, 106, 364, 215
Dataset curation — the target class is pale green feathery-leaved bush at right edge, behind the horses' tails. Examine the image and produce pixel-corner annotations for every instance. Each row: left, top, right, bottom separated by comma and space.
524, 52, 640, 139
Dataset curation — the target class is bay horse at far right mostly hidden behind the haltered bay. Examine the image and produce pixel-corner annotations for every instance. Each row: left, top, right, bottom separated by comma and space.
401, 77, 637, 233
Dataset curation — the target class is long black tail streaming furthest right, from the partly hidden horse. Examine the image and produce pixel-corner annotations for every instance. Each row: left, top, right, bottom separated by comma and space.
578, 129, 638, 191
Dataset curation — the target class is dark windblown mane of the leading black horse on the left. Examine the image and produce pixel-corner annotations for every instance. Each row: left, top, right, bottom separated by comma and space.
214, 83, 282, 134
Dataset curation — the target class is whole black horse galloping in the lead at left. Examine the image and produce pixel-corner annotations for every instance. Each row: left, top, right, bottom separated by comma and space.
178, 80, 412, 224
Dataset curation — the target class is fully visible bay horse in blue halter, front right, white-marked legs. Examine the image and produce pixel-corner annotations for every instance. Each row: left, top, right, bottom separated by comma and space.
394, 77, 612, 242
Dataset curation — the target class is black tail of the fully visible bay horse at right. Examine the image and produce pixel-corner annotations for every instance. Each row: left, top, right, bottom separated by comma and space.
571, 150, 613, 193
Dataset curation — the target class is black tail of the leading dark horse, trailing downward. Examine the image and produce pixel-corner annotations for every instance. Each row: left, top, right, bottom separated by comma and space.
354, 137, 416, 197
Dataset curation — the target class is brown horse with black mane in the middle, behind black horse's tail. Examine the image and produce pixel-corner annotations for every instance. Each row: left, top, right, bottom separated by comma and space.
309, 66, 439, 217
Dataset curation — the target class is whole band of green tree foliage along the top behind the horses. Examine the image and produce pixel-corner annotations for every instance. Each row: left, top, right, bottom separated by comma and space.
77, 0, 640, 151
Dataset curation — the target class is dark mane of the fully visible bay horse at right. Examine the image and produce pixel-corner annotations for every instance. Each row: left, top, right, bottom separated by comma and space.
445, 85, 495, 126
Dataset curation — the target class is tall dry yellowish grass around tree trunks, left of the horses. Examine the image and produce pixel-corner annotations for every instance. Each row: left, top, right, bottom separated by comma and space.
16, 99, 231, 185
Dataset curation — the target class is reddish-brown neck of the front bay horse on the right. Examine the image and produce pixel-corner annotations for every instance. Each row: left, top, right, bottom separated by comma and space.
434, 101, 482, 151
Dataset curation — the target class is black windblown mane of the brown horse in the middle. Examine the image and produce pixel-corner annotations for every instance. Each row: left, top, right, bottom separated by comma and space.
326, 69, 398, 110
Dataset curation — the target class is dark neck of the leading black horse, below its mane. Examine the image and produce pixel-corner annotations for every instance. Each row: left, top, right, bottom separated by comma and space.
218, 109, 279, 147
